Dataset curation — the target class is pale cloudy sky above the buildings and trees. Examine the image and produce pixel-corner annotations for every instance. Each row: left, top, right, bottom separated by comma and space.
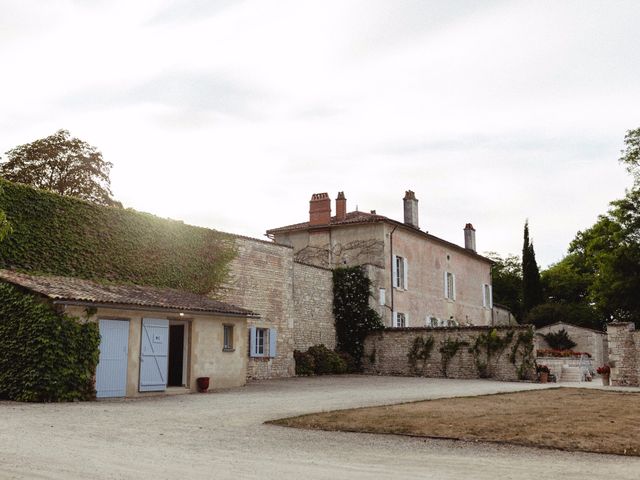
0, 0, 640, 267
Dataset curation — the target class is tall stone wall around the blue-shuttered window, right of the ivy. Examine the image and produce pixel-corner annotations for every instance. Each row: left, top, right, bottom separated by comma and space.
216, 236, 295, 379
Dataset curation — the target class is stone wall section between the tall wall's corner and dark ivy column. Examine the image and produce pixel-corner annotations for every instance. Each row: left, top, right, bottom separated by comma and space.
293, 262, 336, 350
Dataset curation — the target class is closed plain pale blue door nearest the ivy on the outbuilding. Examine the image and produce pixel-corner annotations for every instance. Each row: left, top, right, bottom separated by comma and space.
96, 320, 129, 398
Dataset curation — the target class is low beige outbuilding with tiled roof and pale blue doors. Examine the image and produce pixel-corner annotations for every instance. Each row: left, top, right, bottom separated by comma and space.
0, 270, 260, 398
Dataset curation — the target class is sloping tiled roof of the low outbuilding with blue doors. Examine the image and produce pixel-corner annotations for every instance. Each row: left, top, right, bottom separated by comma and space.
0, 269, 257, 316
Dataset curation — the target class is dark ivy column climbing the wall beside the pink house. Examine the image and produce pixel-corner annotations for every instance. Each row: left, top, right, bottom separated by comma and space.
333, 266, 384, 369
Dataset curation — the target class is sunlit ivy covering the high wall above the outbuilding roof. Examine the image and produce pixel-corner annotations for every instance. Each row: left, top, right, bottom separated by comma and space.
0, 180, 236, 294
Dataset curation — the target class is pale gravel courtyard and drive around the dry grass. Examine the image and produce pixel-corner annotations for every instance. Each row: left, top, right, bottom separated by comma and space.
0, 376, 640, 480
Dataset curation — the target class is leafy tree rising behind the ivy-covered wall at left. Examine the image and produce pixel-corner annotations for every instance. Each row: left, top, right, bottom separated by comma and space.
0, 130, 119, 205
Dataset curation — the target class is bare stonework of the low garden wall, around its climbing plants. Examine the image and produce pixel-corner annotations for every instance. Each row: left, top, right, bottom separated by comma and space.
363, 326, 535, 381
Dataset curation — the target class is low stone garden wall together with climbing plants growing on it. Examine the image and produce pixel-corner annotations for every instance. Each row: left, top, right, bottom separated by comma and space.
363, 325, 535, 381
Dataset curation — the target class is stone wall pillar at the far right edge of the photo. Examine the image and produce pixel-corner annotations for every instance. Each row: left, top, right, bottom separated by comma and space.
607, 322, 640, 387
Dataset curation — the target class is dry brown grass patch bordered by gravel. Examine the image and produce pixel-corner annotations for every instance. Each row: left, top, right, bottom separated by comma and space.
268, 388, 640, 456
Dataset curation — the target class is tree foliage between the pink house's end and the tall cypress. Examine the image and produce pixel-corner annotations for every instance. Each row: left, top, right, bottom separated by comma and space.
485, 252, 522, 320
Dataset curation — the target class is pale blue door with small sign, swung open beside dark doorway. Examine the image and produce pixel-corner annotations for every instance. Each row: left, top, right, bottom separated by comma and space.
139, 318, 169, 392
